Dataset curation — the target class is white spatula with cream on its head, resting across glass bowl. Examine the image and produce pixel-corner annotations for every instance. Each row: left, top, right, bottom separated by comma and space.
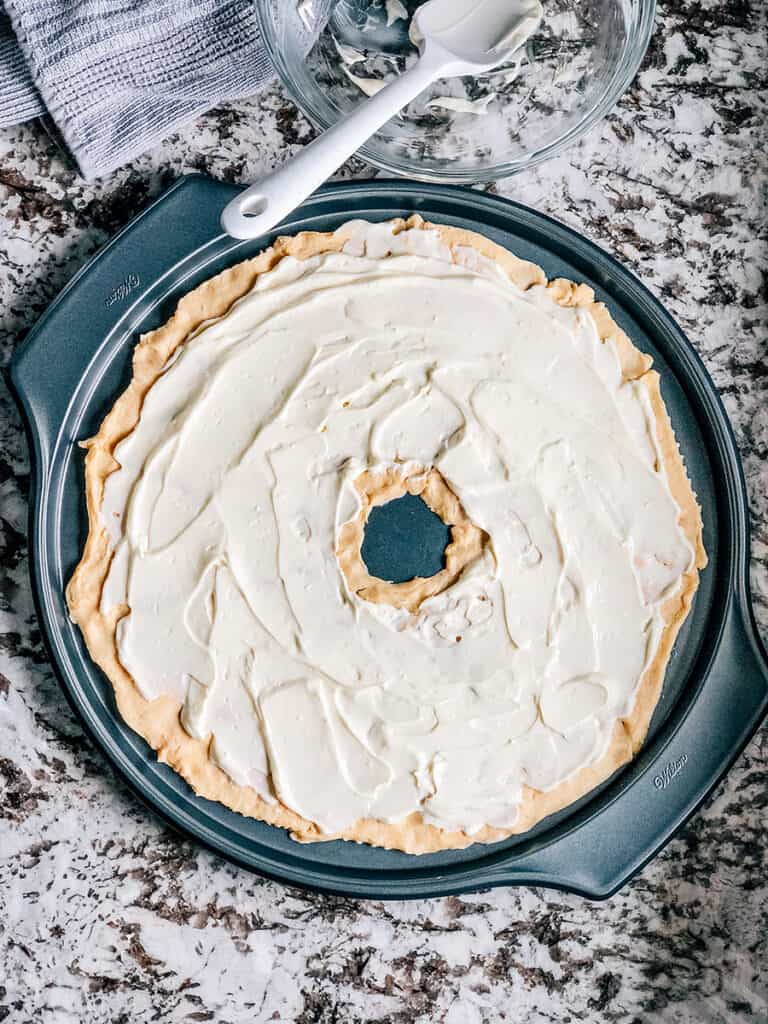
221, 0, 542, 239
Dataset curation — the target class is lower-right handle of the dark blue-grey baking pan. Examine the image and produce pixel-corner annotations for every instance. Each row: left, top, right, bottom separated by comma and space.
477, 589, 768, 899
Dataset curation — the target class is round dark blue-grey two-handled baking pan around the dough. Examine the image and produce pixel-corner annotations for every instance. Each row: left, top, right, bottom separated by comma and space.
11, 177, 768, 898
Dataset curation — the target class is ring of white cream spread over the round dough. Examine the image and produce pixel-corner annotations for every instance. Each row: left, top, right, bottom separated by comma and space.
101, 223, 692, 833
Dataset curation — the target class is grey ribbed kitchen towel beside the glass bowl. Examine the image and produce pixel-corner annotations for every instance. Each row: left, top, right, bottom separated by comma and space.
0, 0, 282, 179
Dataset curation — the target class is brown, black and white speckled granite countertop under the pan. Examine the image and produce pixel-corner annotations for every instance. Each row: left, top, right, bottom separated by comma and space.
0, 0, 768, 1024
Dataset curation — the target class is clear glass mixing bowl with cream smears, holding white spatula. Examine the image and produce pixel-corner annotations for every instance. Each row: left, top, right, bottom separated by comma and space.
256, 0, 655, 182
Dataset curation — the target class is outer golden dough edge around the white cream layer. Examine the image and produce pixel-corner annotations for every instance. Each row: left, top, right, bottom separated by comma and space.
67, 216, 707, 853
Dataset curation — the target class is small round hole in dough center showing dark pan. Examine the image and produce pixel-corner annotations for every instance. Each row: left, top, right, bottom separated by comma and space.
360, 494, 451, 584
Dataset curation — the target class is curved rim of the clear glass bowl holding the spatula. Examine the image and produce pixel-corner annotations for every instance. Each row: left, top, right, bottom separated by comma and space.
255, 0, 656, 184
